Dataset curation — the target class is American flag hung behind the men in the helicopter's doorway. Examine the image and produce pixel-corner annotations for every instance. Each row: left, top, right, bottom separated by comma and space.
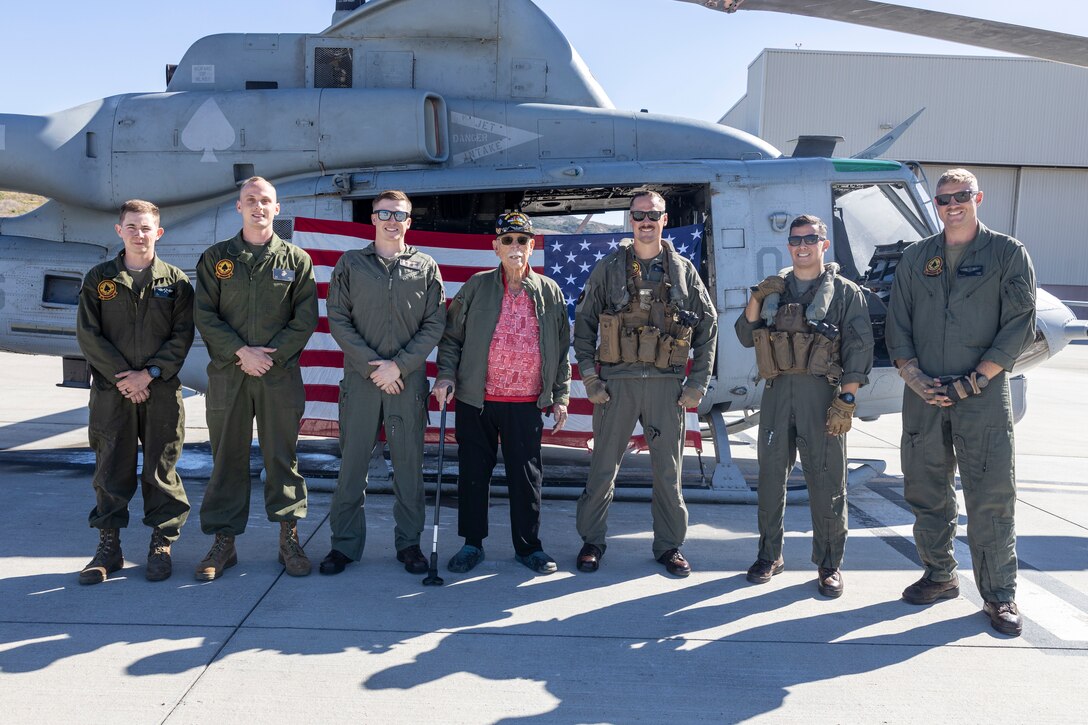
292, 217, 703, 450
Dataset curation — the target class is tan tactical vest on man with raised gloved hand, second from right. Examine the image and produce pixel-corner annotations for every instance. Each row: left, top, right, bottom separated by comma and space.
752, 271, 842, 385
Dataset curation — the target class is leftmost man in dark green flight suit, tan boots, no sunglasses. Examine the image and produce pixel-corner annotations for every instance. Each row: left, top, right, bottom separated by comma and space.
76, 199, 193, 585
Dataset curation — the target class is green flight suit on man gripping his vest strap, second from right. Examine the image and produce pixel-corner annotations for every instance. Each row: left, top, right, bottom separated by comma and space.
734, 267, 873, 569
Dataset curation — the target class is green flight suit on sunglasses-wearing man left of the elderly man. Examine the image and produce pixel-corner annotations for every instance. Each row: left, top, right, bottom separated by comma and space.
327, 244, 446, 553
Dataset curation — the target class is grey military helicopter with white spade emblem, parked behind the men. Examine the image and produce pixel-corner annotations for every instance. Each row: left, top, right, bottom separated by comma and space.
0, 0, 1088, 493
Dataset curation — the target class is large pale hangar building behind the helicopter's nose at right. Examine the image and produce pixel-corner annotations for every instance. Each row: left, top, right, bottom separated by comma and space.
720, 49, 1088, 309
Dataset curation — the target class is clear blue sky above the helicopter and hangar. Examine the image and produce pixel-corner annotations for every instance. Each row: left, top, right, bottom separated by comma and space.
0, 0, 1088, 121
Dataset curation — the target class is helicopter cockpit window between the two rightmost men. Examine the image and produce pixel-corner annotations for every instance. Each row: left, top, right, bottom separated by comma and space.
831, 183, 929, 280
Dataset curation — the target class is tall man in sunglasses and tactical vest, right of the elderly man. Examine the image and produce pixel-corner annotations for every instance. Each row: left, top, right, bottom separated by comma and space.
574, 192, 718, 577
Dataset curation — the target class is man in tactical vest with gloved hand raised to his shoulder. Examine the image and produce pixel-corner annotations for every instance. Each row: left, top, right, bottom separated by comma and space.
734, 214, 873, 598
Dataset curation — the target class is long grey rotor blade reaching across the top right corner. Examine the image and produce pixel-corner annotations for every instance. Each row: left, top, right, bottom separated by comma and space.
680, 0, 1088, 67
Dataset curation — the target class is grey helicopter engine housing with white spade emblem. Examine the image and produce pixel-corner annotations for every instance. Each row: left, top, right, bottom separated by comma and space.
0, 88, 449, 211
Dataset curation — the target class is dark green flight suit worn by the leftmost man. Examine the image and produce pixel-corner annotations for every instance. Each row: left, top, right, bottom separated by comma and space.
76, 251, 193, 541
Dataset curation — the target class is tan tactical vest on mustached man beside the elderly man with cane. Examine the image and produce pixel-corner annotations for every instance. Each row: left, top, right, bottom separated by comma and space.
597, 246, 694, 370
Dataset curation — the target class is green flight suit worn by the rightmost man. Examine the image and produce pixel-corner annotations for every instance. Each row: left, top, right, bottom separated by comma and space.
887, 223, 1036, 602
